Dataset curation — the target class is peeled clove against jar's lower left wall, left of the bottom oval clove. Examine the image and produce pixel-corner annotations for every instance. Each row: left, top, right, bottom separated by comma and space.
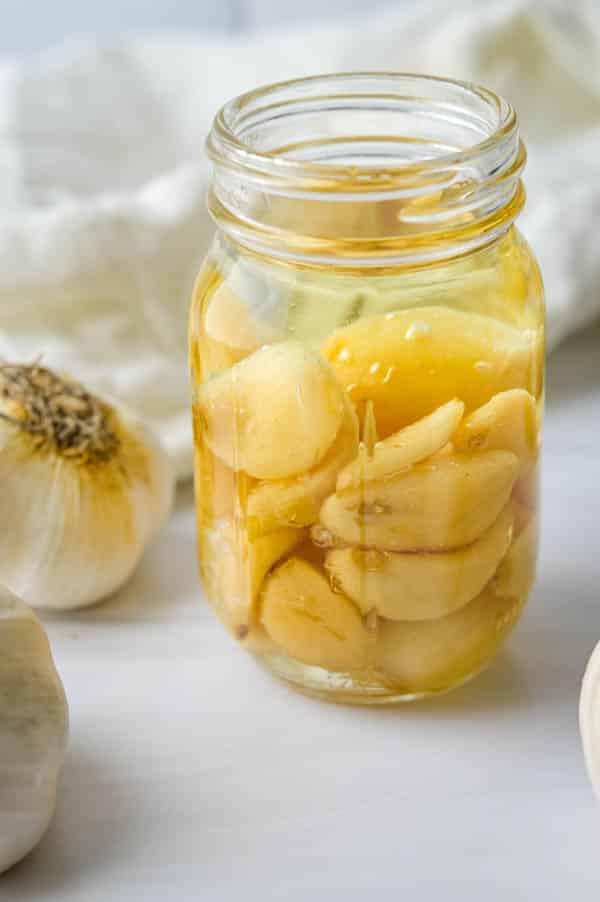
203, 521, 306, 639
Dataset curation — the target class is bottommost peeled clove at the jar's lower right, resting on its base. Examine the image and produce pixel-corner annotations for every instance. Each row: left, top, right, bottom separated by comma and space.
376, 581, 525, 692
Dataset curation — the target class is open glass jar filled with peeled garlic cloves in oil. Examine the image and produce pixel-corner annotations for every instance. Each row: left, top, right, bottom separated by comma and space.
190, 74, 544, 703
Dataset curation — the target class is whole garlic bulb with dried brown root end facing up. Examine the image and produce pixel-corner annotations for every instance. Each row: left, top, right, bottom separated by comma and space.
0, 364, 174, 610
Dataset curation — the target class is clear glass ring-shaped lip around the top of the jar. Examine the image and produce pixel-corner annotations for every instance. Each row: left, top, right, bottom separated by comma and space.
206, 71, 519, 190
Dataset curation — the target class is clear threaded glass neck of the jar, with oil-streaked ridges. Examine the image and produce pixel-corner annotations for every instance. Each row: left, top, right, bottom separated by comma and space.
207, 73, 525, 267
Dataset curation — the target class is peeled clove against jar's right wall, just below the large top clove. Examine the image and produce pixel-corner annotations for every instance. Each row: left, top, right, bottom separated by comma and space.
452, 388, 538, 469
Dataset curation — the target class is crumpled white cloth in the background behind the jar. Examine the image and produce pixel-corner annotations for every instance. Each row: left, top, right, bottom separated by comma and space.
0, 0, 600, 476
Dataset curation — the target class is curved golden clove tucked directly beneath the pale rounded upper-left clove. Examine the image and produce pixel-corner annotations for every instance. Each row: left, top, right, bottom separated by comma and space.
247, 401, 358, 537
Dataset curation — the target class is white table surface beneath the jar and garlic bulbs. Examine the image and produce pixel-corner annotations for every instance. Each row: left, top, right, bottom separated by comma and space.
0, 329, 600, 902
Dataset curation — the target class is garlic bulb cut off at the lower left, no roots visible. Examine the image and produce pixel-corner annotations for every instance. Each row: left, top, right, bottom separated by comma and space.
0, 588, 69, 873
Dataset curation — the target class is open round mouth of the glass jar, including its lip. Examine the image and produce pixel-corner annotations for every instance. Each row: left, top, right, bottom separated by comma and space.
207, 72, 517, 187
